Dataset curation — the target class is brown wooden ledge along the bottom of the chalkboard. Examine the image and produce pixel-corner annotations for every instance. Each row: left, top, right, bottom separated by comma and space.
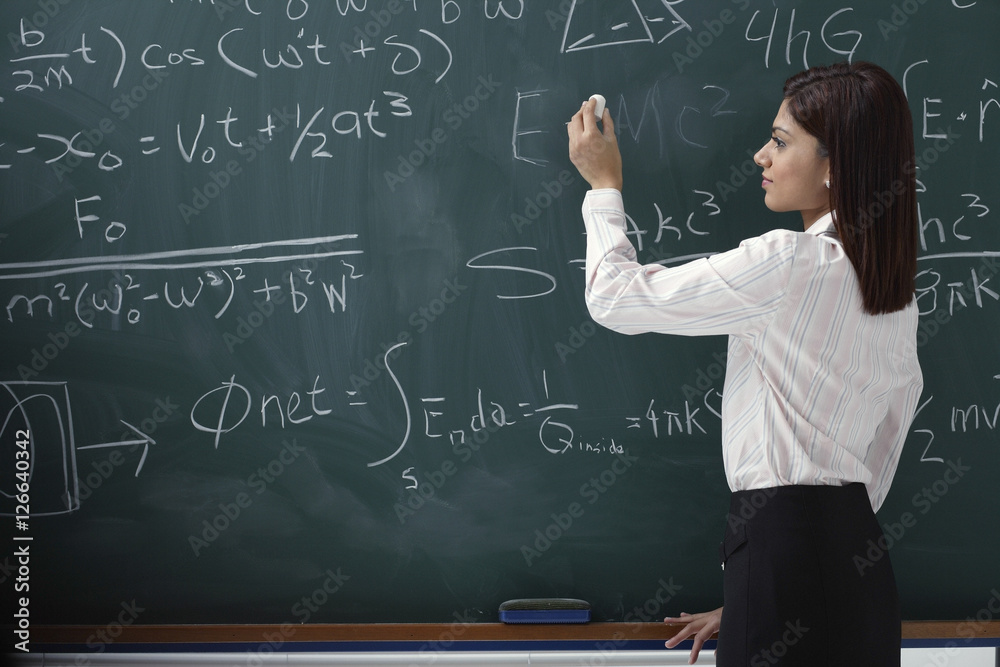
31, 621, 1000, 650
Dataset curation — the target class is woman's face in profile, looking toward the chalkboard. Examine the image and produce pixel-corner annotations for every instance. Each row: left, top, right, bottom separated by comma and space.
754, 100, 830, 229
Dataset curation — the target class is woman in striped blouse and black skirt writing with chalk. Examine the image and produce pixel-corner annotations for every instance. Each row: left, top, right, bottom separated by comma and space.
568, 63, 923, 667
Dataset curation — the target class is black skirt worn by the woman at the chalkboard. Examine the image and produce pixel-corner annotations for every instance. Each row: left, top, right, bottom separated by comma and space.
717, 484, 901, 667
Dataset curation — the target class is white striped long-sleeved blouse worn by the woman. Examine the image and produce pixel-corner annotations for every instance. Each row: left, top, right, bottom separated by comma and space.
583, 190, 923, 510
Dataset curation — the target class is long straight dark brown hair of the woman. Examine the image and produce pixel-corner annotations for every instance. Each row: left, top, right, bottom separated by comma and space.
784, 62, 917, 315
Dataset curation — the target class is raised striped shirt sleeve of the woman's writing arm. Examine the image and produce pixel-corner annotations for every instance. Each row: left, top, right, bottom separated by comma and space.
583, 190, 796, 336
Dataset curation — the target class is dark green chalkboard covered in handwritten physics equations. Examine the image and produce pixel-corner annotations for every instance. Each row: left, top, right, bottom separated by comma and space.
0, 0, 1000, 625
